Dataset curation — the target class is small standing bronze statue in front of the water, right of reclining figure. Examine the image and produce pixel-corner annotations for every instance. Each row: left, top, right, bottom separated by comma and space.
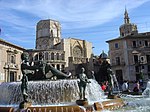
78, 67, 91, 100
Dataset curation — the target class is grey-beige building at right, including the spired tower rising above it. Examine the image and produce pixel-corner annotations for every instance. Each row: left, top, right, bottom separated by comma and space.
106, 10, 150, 81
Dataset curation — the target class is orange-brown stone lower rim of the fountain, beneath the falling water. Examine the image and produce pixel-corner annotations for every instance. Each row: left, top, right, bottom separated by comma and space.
0, 98, 125, 112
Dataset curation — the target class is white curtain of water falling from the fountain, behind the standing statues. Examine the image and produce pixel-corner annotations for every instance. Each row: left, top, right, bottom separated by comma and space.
0, 79, 103, 105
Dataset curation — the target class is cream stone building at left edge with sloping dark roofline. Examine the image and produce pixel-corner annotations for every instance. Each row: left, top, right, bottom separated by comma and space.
0, 39, 25, 82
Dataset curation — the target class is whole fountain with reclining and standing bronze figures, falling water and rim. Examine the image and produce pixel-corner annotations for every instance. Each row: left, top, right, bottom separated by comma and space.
0, 52, 124, 112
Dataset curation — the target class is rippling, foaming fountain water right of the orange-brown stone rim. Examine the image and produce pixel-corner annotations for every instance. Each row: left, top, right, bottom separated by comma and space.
111, 81, 150, 112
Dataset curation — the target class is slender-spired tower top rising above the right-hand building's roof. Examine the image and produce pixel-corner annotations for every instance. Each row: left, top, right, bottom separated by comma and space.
119, 9, 138, 37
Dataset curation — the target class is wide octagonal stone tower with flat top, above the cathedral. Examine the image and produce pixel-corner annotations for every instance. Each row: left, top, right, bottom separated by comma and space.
36, 19, 61, 50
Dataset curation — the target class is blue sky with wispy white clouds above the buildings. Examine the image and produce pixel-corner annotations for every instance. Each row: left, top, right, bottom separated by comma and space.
0, 0, 150, 55
